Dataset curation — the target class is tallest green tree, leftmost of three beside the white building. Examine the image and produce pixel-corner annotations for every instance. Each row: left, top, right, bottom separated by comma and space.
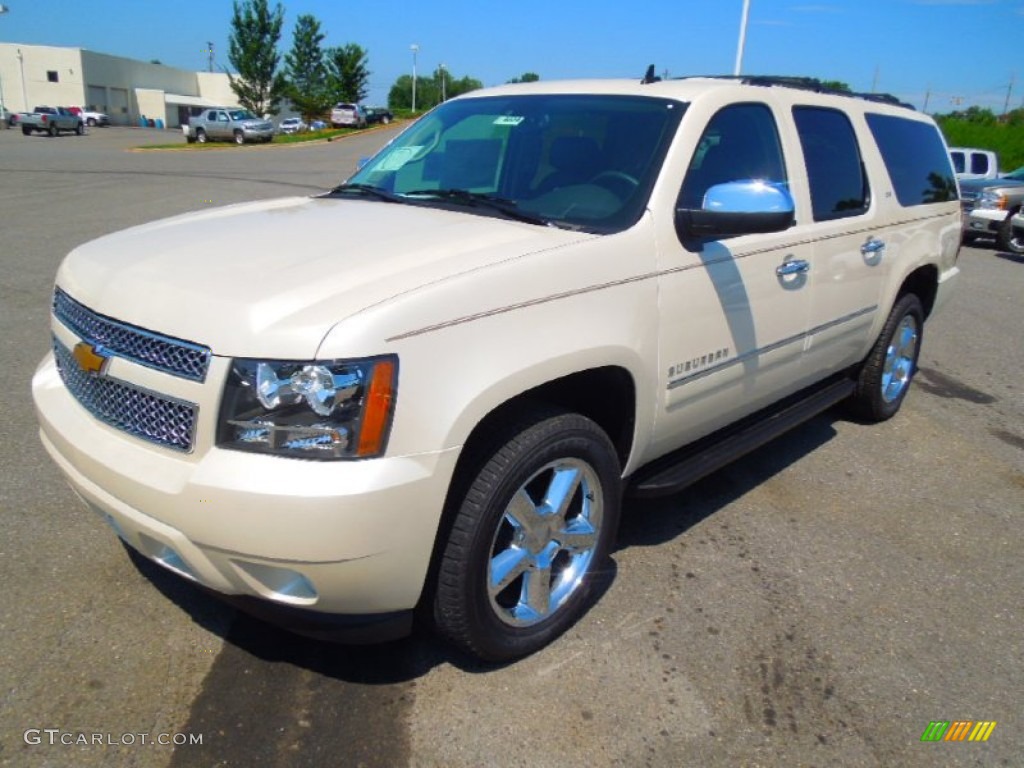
227, 0, 287, 115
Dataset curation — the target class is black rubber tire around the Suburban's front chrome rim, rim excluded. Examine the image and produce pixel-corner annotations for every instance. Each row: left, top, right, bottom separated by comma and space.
435, 414, 622, 662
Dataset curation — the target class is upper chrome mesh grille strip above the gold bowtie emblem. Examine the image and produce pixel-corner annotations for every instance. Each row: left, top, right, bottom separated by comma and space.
53, 288, 211, 381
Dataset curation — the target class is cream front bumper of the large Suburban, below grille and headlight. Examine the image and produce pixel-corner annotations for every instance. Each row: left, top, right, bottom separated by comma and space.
33, 354, 458, 636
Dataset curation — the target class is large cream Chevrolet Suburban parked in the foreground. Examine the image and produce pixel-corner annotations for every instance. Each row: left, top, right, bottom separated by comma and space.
33, 78, 961, 659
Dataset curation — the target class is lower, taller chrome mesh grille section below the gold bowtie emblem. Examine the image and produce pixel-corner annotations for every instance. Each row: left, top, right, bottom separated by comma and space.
53, 339, 199, 452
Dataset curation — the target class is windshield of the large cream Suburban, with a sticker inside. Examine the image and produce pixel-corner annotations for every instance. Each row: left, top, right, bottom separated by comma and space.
349, 94, 685, 232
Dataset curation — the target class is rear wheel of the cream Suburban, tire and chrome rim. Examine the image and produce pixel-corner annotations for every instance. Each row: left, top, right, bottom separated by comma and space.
850, 293, 925, 422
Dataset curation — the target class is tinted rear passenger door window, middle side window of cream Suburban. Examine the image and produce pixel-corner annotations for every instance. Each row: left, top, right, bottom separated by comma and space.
793, 106, 868, 221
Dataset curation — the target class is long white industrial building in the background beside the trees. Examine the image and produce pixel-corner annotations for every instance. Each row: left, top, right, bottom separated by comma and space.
0, 43, 239, 128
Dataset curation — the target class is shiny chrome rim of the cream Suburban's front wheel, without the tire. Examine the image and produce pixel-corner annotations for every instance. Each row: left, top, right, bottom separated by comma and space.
487, 459, 603, 627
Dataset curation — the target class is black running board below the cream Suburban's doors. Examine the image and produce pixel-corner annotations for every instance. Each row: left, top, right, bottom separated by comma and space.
629, 377, 857, 498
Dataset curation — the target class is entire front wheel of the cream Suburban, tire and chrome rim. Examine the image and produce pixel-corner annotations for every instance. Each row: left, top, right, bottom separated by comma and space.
434, 407, 622, 662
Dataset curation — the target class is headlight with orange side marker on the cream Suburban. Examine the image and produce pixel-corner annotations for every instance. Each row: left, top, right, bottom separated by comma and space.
217, 356, 398, 459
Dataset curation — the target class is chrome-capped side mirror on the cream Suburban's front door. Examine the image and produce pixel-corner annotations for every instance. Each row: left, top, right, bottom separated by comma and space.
676, 179, 796, 240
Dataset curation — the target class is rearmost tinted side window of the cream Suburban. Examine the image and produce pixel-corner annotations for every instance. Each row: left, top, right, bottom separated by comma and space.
866, 114, 956, 207
